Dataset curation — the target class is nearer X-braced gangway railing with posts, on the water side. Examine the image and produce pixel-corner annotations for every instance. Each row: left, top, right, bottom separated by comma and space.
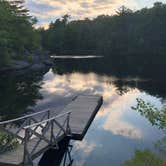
23, 112, 71, 166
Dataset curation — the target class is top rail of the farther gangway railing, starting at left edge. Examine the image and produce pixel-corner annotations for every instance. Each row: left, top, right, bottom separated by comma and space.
0, 110, 50, 125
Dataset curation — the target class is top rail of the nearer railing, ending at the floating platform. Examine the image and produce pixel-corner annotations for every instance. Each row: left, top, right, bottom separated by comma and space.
24, 111, 71, 130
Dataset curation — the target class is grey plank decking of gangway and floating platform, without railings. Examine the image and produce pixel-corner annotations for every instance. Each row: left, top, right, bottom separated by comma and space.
0, 95, 103, 166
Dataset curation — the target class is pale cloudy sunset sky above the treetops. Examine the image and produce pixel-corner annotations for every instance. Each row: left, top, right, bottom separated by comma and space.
25, 0, 166, 28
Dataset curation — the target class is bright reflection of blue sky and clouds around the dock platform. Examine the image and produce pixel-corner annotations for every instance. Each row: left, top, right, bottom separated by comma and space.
37, 70, 164, 166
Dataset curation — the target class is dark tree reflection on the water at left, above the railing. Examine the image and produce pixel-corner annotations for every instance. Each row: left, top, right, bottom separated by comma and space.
0, 70, 47, 120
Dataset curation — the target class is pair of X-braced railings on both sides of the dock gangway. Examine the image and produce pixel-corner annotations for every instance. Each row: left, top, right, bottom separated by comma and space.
0, 110, 71, 166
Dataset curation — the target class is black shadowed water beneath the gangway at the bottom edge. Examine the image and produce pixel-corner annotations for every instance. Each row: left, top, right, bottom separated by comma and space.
39, 138, 73, 166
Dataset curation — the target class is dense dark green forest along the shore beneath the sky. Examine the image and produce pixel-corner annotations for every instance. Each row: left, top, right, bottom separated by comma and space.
0, 0, 166, 72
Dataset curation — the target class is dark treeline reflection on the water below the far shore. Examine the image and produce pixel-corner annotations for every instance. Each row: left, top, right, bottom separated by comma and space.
53, 58, 166, 98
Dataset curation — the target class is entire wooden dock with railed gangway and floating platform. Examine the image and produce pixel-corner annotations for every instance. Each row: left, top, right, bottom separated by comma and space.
0, 95, 103, 166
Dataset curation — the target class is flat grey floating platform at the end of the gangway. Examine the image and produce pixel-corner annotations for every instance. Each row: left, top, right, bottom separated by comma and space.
63, 95, 103, 140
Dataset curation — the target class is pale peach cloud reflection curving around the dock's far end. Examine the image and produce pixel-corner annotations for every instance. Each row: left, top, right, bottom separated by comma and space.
42, 70, 158, 139
